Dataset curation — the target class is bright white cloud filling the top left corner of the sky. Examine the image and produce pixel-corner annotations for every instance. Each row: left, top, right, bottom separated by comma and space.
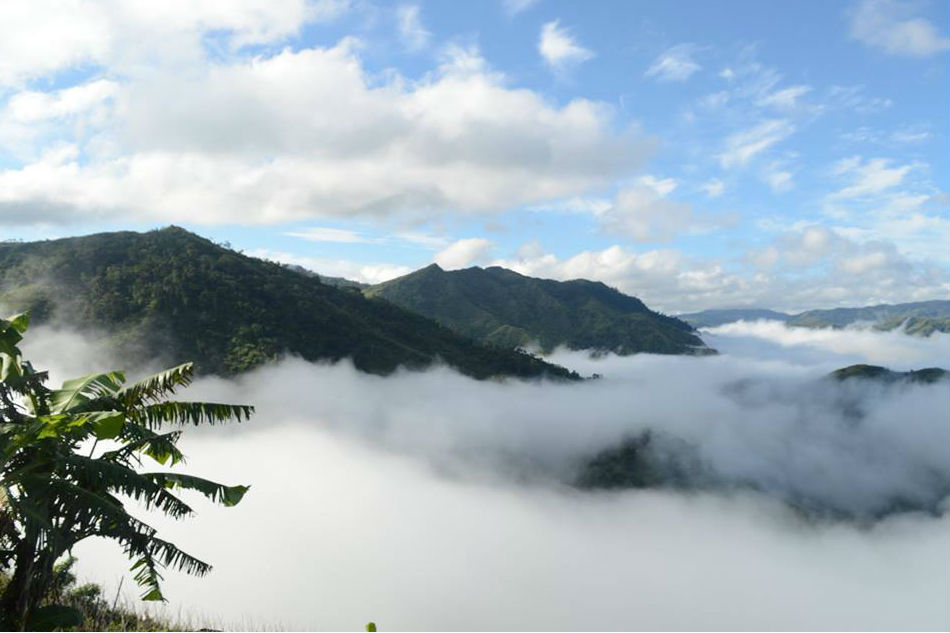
0, 0, 334, 86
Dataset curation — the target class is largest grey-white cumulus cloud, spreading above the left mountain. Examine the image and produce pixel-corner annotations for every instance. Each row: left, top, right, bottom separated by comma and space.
0, 40, 652, 223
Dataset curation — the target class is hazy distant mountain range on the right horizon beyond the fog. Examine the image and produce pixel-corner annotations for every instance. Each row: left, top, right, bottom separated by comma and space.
679, 301, 950, 336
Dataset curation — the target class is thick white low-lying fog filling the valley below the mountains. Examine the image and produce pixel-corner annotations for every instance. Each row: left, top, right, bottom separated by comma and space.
25, 322, 950, 630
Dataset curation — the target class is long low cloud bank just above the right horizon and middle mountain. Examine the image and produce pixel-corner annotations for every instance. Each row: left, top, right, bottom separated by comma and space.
493, 223, 950, 313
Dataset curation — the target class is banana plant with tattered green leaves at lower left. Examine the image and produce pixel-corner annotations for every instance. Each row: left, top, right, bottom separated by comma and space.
0, 314, 254, 630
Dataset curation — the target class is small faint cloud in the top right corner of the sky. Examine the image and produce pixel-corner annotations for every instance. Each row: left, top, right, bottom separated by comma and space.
851, 0, 950, 57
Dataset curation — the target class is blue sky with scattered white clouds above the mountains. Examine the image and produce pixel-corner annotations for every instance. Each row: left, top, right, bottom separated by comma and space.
0, 0, 950, 313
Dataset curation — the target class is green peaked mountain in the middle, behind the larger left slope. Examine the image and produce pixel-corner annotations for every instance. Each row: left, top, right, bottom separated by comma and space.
363, 264, 714, 354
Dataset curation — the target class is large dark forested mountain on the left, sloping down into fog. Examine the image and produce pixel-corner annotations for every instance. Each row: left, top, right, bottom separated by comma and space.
0, 227, 577, 378
